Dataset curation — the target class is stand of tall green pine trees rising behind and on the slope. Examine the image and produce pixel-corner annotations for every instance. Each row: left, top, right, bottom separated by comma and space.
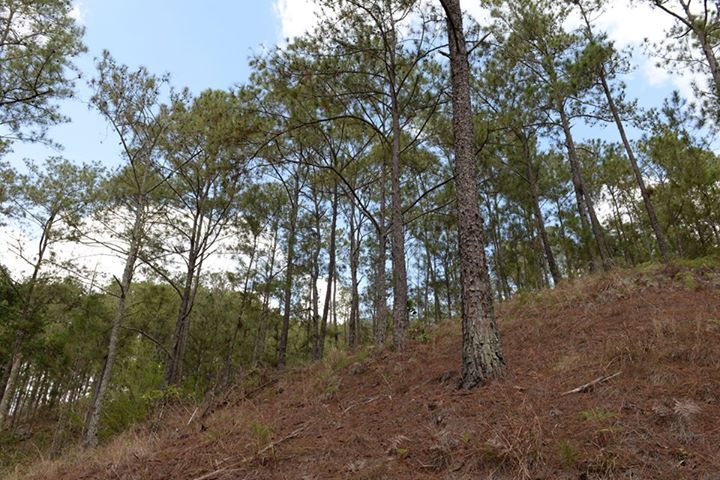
0, 0, 720, 458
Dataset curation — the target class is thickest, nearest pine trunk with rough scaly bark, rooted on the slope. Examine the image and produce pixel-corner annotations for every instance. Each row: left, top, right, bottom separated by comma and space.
441, 0, 505, 388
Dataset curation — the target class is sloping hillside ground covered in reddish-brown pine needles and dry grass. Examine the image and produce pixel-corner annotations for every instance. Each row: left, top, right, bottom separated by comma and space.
8, 265, 720, 480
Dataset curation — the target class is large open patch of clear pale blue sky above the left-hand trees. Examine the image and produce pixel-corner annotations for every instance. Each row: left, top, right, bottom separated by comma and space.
6, 0, 283, 172
